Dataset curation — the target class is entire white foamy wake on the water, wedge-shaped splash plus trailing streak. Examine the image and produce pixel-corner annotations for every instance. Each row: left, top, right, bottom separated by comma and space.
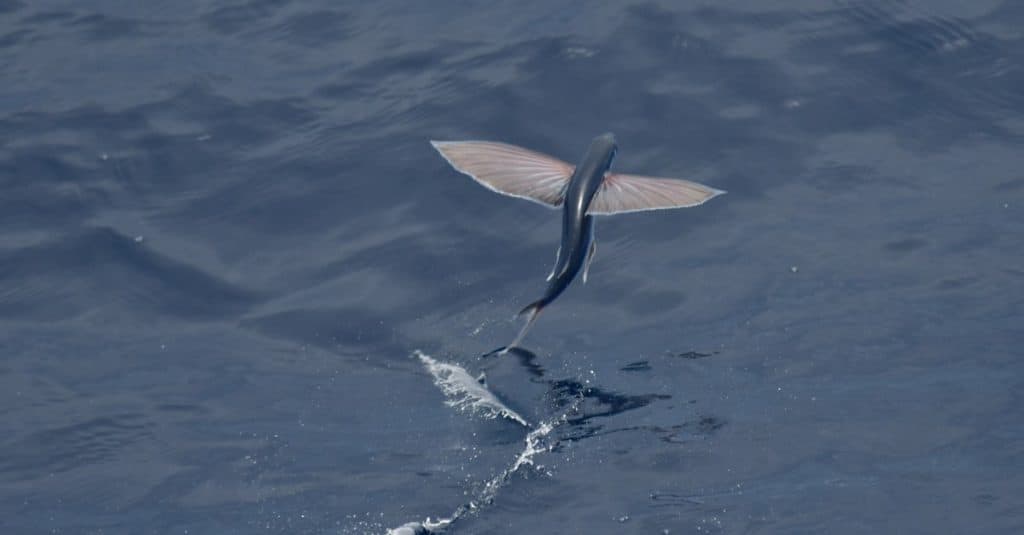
387, 351, 574, 535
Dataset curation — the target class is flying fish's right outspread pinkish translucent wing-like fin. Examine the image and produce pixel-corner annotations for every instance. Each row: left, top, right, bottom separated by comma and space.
587, 173, 725, 215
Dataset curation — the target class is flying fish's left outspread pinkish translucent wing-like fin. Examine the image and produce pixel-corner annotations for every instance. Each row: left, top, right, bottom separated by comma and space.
430, 141, 574, 208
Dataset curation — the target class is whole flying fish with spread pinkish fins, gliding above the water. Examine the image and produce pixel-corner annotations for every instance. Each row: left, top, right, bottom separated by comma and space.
431, 133, 725, 353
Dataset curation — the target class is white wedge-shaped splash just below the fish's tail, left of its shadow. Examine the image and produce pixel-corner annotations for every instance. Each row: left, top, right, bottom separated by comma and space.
413, 349, 529, 427
